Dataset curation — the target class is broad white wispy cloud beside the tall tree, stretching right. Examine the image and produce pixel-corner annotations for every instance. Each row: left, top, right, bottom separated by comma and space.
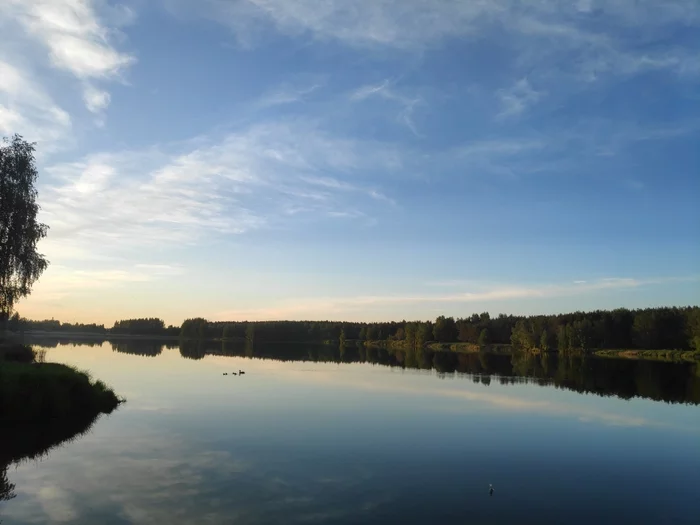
40, 121, 394, 258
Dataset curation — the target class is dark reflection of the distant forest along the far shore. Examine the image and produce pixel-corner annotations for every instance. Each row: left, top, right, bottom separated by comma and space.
23, 338, 700, 405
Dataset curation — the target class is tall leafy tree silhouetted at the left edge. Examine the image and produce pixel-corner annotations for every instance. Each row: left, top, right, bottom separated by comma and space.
0, 135, 49, 319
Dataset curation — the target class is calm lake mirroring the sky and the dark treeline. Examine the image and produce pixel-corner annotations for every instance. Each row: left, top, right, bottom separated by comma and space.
0, 340, 700, 525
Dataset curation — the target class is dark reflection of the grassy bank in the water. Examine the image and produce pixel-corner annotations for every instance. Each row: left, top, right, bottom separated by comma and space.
0, 416, 97, 510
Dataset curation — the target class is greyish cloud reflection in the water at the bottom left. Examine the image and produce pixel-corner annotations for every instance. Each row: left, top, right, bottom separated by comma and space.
5, 434, 388, 524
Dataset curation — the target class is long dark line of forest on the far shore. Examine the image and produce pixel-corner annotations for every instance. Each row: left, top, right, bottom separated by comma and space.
8, 306, 700, 351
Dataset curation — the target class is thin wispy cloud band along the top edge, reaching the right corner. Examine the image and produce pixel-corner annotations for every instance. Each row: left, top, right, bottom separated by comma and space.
176, 0, 700, 80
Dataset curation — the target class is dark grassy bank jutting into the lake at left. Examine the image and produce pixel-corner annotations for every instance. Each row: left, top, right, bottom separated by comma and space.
0, 344, 121, 424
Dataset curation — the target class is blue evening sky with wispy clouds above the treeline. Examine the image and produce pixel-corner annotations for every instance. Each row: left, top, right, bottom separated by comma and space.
0, 0, 700, 326
